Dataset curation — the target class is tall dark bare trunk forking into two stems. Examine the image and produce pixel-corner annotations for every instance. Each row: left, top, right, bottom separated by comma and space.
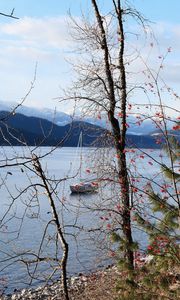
92, 0, 133, 269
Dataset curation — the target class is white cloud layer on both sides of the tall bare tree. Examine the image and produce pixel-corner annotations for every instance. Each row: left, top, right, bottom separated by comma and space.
0, 16, 180, 113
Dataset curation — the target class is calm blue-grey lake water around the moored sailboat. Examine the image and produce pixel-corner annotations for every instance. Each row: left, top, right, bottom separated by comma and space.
0, 147, 168, 292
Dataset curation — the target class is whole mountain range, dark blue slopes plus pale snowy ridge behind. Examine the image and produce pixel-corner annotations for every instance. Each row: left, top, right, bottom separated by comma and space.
0, 102, 174, 148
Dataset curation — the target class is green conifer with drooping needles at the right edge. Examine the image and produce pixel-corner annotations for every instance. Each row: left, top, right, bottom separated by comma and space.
132, 131, 180, 299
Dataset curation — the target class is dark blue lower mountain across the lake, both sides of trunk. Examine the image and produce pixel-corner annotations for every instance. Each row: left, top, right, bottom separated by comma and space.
0, 111, 162, 148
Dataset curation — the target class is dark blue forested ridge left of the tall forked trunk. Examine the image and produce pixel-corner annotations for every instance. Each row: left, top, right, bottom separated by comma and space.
0, 111, 105, 147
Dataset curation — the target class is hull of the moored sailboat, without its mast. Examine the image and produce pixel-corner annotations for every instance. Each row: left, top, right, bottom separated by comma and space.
70, 181, 99, 193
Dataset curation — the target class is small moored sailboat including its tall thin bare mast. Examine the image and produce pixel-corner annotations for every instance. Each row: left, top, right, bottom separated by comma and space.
70, 132, 99, 193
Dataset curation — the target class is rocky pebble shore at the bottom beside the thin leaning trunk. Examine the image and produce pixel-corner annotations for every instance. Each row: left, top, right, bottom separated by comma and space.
0, 266, 118, 300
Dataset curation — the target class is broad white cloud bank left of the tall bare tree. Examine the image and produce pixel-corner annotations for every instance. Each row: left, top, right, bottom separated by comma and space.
0, 17, 76, 107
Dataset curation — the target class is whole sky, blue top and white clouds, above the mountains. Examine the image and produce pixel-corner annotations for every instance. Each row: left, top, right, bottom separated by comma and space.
0, 0, 180, 113
